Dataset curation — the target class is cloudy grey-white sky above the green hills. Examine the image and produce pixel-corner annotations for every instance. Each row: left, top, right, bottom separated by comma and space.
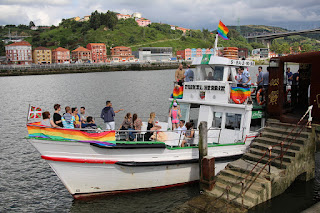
0, 0, 320, 30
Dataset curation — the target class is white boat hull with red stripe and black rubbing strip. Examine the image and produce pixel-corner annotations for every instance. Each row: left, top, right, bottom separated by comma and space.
29, 139, 246, 198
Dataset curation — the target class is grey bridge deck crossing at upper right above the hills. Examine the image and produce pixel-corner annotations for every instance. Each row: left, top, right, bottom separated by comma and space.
245, 28, 320, 48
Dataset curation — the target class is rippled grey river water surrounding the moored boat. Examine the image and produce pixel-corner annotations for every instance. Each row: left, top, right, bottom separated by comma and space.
0, 68, 320, 212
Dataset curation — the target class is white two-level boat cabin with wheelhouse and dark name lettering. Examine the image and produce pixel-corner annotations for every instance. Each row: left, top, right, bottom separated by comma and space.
169, 55, 254, 143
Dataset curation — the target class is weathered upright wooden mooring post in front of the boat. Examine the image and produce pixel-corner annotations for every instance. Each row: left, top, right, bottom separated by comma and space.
199, 121, 208, 190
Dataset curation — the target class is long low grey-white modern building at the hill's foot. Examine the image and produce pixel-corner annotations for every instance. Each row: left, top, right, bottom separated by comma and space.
138, 47, 172, 61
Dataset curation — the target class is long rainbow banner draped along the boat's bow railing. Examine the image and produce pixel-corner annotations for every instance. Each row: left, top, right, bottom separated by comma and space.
27, 122, 116, 145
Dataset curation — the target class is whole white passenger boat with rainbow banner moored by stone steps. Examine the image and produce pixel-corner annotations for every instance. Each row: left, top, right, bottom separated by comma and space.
27, 50, 263, 198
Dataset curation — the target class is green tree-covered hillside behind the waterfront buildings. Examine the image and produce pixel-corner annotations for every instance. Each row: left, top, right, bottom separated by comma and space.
0, 11, 319, 55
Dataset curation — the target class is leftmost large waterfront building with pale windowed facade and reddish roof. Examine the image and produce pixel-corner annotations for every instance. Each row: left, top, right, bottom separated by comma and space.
5, 41, 32, 64
